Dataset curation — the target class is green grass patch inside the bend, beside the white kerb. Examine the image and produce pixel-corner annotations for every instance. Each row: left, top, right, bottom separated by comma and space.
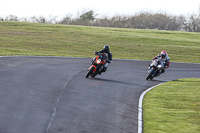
143, 78, 200, 133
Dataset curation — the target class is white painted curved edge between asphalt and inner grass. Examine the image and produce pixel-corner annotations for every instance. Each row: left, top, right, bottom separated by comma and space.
138, 83, 163, 133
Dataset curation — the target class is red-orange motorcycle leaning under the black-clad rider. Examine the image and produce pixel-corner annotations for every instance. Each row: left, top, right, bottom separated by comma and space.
85, 53, 107, 78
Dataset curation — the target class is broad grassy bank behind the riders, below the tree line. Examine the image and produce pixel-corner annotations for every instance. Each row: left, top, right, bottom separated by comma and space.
0, 22, 200, 63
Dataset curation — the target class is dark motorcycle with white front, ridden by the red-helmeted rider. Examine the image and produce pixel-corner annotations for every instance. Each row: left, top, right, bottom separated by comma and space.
146, 59, 164, 80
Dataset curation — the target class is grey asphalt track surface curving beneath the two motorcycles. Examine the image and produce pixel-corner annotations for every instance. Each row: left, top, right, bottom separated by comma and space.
0, 57, 200, 133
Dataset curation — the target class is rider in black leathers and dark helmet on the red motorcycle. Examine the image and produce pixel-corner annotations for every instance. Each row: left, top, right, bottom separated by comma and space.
91, 45, 112, 74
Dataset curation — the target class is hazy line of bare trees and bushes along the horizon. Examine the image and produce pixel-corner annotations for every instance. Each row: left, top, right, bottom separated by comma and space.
0, 10, 200, 32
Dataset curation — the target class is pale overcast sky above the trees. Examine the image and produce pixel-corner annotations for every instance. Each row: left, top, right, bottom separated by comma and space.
0, 0, 200, 17
